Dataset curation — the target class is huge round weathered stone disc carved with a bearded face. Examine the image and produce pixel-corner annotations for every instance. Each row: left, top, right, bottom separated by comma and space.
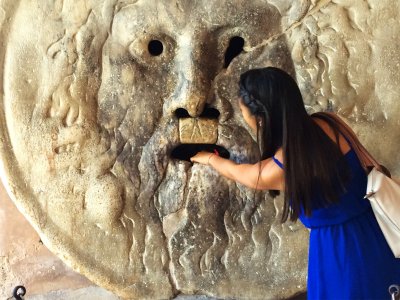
0, 0, 400, 299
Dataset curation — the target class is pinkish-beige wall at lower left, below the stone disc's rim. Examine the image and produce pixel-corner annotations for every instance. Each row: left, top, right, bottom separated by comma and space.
0, 179, 99, 299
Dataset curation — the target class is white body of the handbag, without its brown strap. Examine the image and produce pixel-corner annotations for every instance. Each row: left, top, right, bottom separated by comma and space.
365, 167, 400, 258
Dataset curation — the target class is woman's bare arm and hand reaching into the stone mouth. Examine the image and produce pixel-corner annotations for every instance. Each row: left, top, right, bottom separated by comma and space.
190, 152, 284, 190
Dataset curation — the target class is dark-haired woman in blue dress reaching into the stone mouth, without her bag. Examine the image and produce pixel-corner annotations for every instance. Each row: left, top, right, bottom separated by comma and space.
191, 67, 400, 299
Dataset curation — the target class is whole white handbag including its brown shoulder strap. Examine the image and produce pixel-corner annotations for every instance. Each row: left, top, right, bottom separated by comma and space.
313, 112, 400, 258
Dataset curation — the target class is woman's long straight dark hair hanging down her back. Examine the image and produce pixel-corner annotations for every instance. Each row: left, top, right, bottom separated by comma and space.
239, 67, 348, 222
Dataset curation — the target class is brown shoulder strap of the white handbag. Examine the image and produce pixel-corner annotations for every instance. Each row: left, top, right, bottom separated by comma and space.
311, 112, 383, 173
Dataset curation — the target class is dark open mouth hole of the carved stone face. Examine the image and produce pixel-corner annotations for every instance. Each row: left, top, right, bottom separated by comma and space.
171, 144, 230, 161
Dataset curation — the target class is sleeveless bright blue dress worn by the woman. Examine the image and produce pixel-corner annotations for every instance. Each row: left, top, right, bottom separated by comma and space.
274, 150, 400, 300
